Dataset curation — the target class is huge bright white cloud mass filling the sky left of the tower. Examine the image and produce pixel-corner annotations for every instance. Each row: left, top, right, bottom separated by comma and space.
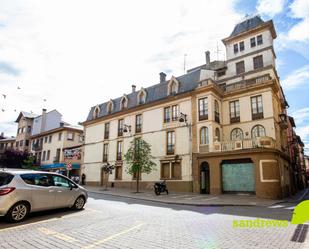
0, 0, 240, 136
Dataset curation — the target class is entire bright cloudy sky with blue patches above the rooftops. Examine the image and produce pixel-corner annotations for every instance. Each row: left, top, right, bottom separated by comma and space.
0, 0, 309, 154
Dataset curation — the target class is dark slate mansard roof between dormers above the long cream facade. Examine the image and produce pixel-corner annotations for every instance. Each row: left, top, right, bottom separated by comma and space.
87, 69, 201, 121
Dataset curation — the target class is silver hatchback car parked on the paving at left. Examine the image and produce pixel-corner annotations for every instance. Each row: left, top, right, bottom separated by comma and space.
0, 169, 88, 222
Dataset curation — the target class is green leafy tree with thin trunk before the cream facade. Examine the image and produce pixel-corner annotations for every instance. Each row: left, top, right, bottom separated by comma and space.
124, 138, 156, 193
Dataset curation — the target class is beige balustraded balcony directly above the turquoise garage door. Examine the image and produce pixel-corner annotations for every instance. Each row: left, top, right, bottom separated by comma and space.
199, 137, 276, 153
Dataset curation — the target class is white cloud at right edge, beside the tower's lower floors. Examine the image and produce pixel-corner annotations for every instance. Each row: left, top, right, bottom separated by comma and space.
282, 65, 309, 89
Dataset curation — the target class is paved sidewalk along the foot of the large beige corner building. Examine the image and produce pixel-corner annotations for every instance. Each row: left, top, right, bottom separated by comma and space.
86, 186, 298, 207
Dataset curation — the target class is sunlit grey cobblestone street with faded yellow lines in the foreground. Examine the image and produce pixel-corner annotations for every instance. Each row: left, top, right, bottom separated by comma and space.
0, 194, 309, 249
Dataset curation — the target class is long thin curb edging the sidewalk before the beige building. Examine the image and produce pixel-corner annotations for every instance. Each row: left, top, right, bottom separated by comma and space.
87, 190, 268, 207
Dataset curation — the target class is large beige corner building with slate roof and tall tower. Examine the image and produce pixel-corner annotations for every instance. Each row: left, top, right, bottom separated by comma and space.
82, 16, 293, 198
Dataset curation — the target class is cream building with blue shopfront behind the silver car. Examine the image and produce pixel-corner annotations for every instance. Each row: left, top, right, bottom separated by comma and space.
30, 109, 83, 174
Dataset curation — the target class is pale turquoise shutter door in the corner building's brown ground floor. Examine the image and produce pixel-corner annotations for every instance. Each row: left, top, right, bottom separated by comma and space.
222, 161, 255, 192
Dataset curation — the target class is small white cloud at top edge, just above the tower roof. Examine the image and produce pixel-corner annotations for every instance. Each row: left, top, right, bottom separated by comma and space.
256, 0, 285, 18
